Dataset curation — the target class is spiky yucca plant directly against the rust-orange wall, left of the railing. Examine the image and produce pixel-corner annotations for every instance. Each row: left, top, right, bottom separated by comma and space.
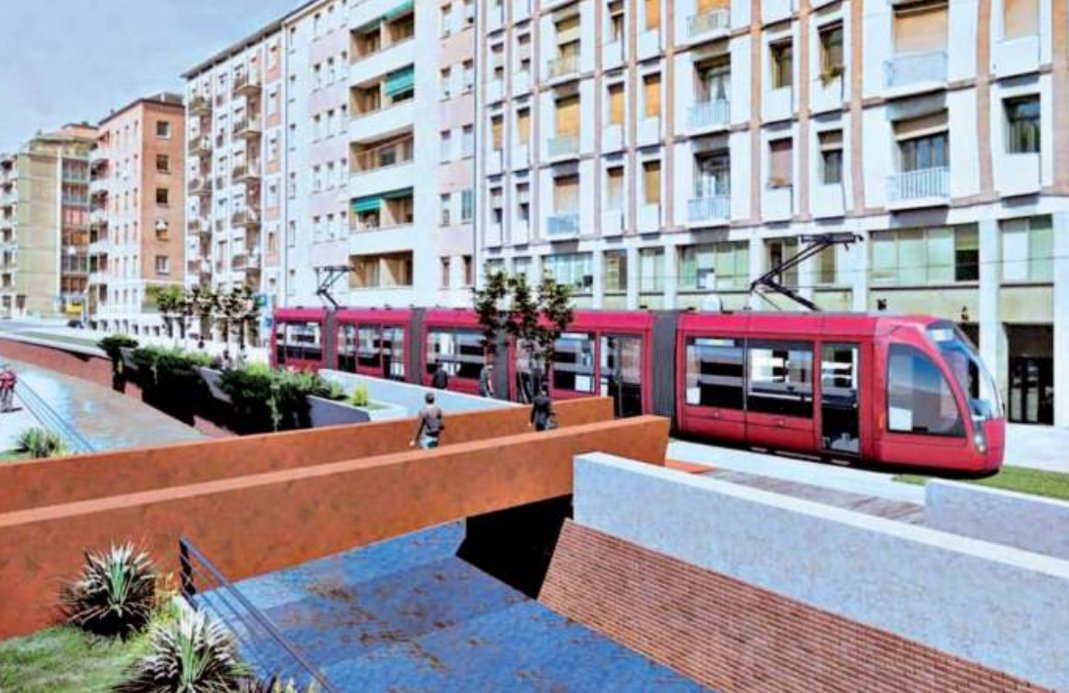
60, 543, 157, 637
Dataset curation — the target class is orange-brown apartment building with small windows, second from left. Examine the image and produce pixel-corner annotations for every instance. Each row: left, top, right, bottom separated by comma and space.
89, 93, 186, 335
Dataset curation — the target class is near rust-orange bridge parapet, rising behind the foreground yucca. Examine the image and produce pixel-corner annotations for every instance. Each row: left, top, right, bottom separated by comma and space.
0, 416, 669, 638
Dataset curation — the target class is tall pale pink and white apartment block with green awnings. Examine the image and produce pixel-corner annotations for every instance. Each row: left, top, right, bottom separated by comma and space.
185, 0, 475, 318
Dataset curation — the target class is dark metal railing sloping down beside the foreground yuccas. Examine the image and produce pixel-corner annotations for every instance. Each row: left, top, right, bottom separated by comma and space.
179, 537, 339, 693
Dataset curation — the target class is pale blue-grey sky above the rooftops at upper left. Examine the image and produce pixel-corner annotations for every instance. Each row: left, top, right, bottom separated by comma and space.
0, 0, 304, 152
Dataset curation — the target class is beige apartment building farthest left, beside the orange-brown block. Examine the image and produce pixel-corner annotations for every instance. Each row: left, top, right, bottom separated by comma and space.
0, 124, 96, 320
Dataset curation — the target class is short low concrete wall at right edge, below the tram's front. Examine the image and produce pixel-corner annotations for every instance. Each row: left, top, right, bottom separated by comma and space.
925, 479, 1069, 558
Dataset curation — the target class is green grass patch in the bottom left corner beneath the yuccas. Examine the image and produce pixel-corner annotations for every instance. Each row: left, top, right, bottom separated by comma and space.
0, 626, 156, 693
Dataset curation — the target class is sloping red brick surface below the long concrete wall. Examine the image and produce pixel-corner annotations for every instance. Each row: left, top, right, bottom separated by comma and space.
540, 522, 1047, 693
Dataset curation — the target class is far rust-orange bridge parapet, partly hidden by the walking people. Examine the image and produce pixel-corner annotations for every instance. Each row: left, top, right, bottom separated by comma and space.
0, 398, 613, 512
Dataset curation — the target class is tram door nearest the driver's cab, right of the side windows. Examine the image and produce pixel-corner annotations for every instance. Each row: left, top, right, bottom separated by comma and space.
820, 344, 861, 455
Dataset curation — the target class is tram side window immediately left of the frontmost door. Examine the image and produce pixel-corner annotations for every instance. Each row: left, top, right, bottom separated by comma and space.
746, 342, 812, 418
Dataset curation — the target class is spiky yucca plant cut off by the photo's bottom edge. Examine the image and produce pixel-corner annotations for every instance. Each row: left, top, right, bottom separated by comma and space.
115, 612, 250, 693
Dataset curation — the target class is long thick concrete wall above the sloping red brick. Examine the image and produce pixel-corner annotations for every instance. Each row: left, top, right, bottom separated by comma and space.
574, 455, 1069, 688
